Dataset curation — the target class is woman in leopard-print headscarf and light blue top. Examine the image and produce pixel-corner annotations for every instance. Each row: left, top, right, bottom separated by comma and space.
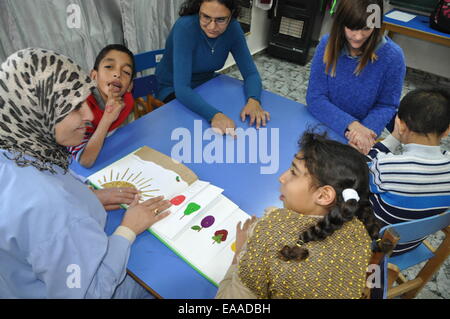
0, 49, 170, 298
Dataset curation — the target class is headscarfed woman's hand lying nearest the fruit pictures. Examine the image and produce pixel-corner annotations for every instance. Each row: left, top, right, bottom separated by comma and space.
121, 195, 172, 235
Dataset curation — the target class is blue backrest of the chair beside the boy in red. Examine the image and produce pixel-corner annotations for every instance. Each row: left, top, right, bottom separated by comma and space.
133, 50, 164, 98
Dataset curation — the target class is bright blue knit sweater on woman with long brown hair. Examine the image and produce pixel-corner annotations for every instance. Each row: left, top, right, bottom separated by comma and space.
306, 35, 406, 135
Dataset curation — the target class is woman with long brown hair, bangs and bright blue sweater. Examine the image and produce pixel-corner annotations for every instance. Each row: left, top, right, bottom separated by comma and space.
306, 0, 406, 154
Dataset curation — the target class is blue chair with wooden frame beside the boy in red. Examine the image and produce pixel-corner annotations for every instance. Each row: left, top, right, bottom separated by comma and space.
133, 50, 164, 119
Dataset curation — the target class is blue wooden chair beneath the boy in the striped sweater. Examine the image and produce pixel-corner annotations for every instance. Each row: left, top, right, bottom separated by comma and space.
380, 211, 450, 298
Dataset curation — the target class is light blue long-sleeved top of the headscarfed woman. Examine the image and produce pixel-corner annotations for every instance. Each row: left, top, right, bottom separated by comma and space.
0, 150, 131, 298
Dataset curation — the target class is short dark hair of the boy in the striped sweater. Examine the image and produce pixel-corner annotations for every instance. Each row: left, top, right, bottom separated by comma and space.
398, 89, 450, 135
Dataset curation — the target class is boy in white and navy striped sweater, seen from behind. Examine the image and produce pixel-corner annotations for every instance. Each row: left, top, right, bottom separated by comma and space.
368, 89, 450, 255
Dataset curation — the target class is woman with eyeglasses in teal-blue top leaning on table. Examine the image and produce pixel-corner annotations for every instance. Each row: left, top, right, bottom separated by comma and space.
156, 0, 270, 135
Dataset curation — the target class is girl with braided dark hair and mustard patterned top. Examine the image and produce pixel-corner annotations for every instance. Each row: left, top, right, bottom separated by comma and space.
216, 132, 379, 298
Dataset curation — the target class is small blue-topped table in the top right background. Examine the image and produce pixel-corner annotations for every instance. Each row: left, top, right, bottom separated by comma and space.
382, 9, 450, 46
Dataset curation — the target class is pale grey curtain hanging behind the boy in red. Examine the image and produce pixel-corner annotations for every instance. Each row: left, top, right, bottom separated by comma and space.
0, 0, 184, 70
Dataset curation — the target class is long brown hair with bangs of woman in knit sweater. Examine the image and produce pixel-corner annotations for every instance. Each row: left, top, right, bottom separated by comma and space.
323, 0, 383, 76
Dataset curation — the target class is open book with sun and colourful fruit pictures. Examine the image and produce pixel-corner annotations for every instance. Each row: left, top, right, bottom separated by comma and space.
88, 146, 250, 286
